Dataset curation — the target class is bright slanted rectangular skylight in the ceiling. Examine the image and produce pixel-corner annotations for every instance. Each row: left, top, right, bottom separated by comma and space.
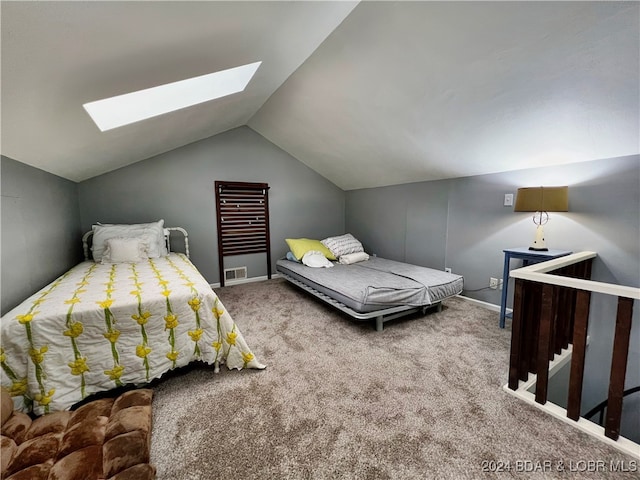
83, 62, 262, 132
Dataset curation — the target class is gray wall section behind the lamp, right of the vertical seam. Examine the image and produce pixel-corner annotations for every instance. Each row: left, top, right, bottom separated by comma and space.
447, 155, 640, 304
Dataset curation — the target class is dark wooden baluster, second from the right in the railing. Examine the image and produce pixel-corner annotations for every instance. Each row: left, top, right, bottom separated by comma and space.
567, 290, 591, 421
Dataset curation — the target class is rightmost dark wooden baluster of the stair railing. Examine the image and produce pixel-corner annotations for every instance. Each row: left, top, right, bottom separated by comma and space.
604, 297, 633, 440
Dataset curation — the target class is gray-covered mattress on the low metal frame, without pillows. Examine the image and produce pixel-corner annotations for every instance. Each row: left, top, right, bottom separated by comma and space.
276, 257, 464, 313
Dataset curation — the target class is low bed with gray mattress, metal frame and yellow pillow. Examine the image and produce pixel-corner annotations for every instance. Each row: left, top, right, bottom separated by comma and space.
276, 234, 464, 331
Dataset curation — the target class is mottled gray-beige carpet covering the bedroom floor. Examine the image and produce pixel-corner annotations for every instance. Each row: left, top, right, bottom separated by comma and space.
151, 279, 638, 480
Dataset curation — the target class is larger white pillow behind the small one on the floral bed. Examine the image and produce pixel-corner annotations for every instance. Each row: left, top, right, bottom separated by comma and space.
91, 219, 168, 263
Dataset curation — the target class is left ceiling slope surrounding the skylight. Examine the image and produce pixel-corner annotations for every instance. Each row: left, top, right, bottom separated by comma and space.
1, 1, 357, 181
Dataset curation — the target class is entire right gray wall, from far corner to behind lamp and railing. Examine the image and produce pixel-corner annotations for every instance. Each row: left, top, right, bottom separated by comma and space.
346, 155, 640, 432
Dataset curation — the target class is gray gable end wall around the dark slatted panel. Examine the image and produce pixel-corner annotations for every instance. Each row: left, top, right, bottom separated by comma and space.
79, 127, 345, 283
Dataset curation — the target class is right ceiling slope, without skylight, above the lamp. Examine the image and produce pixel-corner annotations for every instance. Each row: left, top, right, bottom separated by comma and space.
249, 2, 640, 190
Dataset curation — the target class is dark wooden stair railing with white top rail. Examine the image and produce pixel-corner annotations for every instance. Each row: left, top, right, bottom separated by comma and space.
508, 252, 640, 440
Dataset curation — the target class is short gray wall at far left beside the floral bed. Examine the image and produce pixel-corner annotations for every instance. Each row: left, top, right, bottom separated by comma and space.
0, 156, 82, 315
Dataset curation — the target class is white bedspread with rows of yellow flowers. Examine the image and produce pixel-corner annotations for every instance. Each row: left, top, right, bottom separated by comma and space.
0, 253, 264, 415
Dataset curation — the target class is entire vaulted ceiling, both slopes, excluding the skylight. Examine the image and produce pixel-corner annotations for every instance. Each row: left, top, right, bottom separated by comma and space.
0, 1, 640, 190
